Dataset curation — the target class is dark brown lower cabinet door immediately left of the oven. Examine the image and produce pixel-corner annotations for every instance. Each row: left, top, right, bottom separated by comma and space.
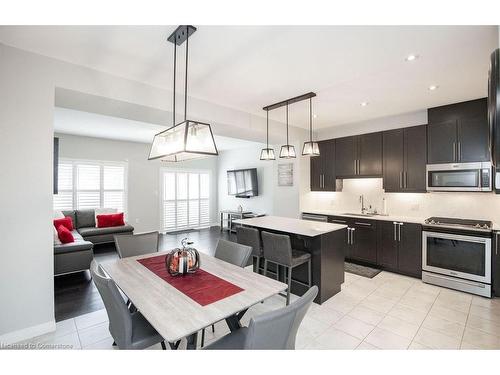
398, 223, 422, 278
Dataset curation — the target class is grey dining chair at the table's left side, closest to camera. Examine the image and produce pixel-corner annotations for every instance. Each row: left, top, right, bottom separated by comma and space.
90, 260, 166, 350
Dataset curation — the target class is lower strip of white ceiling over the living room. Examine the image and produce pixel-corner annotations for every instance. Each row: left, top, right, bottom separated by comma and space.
54, 107, 263, 151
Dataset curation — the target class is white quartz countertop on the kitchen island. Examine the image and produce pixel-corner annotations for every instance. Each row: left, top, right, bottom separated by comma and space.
233, 216, 347, 237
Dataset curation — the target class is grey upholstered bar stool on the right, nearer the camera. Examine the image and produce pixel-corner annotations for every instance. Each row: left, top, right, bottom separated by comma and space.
262, 231, 312, 305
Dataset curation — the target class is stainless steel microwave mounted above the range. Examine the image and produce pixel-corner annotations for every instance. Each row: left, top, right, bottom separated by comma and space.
427, 162, 493, 191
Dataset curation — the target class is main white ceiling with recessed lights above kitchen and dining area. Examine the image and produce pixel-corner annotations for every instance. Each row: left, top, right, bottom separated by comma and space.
0, 26, 498, 127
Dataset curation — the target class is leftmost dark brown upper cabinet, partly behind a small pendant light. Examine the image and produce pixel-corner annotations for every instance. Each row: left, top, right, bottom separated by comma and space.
310, 139, 336, 191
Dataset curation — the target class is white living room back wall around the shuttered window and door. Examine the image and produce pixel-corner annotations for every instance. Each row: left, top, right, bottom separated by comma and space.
56, 134, 217, 232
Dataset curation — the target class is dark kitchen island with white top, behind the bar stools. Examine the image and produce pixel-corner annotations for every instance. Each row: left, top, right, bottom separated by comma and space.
234, 216, 347, 304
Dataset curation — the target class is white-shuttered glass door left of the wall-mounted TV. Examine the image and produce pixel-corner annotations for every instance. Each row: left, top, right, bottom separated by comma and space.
162, 170, 210, 232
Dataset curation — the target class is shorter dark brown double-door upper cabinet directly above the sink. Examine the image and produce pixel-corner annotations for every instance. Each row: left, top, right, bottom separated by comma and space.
335, 132, 382, 178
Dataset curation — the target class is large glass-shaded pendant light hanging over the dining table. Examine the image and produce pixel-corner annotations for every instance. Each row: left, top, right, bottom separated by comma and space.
148, 25, 219, 162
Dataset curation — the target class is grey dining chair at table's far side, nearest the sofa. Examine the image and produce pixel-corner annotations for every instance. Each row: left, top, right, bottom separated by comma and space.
114, 232, 160, 258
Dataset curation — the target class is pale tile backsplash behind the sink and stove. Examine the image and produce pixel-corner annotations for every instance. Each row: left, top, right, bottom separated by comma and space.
300, 178, 500, 222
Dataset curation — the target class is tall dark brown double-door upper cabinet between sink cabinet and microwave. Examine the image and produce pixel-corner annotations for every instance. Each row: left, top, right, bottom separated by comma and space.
383, 125, 427, 192
